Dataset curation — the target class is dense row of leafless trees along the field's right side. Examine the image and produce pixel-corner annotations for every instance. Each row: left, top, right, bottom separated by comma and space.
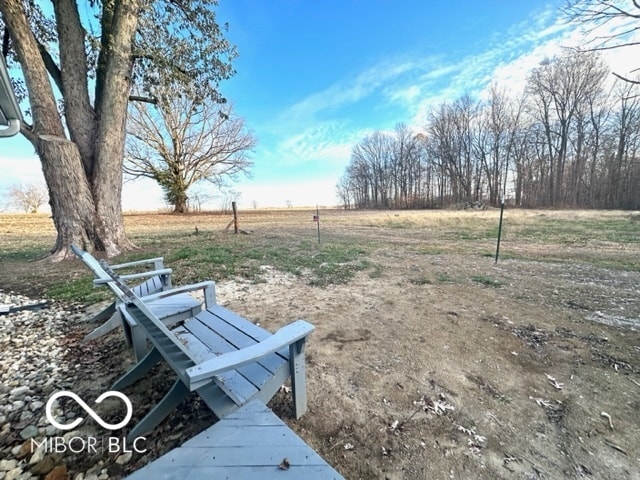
337, 53, 640, 209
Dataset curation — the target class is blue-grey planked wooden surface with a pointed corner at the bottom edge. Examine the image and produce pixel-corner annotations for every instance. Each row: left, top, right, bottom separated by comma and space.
127, 401, 343, 480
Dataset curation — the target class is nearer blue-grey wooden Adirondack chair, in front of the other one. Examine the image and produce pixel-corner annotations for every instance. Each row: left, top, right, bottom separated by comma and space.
102, 262, 313, 440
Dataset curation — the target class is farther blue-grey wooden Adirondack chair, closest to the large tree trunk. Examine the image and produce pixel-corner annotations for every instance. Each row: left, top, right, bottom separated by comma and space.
71, 244, 205, 358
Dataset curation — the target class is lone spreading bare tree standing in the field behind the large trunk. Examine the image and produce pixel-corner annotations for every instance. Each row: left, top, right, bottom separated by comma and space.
125, 95, 256, 213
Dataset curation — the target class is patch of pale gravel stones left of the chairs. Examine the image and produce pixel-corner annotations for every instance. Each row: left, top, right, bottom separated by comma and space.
0, 291, 215, 480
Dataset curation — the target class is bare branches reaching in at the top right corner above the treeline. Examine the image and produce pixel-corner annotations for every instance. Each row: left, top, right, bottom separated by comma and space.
563, 0, 640, 84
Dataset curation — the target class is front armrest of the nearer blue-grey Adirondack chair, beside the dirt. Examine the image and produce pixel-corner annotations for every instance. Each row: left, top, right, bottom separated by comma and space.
186, 320, 314, 391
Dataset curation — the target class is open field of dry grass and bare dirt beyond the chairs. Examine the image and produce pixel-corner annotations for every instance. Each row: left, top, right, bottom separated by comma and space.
0, 210, 640, 480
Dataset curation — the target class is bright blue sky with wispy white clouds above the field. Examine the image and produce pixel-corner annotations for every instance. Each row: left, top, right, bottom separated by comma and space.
0, 0, 640, 211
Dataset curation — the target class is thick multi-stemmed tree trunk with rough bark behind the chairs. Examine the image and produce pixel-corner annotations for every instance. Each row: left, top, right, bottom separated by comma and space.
0, 0, 139, 260
